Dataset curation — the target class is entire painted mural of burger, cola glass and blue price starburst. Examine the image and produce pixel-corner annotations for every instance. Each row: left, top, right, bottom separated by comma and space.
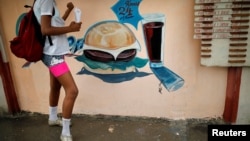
17, 0, 184, 92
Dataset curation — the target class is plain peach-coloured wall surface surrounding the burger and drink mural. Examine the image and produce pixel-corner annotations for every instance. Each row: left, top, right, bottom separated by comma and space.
0, 0, 237, 119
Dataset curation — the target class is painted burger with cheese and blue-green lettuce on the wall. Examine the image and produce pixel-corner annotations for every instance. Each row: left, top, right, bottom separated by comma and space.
76, 21, 148, 74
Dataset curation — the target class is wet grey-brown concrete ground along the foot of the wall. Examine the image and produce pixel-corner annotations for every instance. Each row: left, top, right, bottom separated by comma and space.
0, 112, 223, 141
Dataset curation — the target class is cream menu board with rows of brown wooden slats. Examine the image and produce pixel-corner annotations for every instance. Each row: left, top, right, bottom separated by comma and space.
194, 0, 250, 67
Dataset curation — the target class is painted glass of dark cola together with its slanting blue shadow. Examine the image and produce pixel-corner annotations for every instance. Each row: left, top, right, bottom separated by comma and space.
141, 13, 184, 92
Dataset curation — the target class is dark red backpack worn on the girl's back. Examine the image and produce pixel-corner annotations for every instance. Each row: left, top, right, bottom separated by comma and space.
10, 1, 53, 62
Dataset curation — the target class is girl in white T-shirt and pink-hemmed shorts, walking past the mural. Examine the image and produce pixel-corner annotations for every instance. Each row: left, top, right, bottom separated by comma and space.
34, 0, 82, 141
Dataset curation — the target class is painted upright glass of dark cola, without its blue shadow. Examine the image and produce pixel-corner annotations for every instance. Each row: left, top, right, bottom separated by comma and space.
141, 13, 165, 67
